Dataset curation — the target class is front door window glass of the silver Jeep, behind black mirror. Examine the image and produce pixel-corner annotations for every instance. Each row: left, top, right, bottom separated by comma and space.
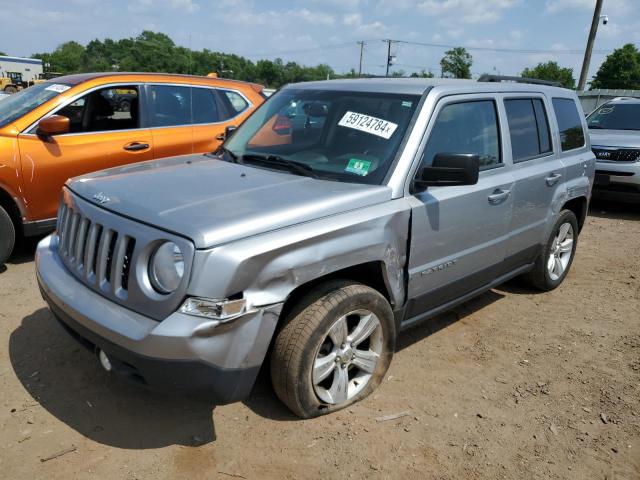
422, 100, 502, 168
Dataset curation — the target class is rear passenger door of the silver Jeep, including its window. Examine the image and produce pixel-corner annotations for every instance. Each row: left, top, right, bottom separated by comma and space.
503, 94, 565, 267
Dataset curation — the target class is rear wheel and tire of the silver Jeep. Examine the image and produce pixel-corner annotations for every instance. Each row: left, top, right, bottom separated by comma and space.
523, 210, 578, 292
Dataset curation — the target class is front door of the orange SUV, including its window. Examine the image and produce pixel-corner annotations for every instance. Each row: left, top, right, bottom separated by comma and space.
18, 85, 153, 220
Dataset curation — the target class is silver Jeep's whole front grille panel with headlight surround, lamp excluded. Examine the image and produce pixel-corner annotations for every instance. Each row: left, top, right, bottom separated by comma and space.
57, 187, 195, 320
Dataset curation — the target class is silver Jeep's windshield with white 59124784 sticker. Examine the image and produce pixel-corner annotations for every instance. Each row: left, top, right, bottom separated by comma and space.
224, 89, 420, 184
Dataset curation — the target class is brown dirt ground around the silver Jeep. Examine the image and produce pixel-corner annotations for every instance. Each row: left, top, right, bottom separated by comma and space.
0, 203, 640, 480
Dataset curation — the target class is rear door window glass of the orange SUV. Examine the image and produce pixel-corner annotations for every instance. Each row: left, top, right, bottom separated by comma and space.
149, 85, 191, 127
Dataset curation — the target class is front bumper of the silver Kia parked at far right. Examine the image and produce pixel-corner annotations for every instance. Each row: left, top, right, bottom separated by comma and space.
593, 161, 640, 202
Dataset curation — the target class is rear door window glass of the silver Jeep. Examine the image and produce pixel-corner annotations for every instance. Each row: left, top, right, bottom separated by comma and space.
504, 98, 551, 163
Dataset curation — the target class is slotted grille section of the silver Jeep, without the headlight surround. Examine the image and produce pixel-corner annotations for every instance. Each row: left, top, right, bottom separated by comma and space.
58, 203, 136, 299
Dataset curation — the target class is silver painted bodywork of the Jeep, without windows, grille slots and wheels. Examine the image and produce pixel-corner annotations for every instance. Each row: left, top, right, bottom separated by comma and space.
36, 79, 595, 400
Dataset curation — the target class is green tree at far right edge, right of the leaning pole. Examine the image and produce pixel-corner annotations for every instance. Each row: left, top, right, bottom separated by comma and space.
591, 43, 640, 90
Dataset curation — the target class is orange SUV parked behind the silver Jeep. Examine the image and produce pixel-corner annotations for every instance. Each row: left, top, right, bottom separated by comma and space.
0, 73, 265, 265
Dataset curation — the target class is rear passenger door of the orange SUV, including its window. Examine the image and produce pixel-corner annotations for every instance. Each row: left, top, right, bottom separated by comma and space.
146, 84, 193, 158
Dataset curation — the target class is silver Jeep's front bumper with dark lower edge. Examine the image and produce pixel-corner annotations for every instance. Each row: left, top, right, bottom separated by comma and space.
36, 235, 282, 403
